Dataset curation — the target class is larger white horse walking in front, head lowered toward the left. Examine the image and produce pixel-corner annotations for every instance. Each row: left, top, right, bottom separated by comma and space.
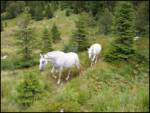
39, 51, 80, 84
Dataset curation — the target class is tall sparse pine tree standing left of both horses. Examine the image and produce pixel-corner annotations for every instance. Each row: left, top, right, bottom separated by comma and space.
15, 12, 34, 62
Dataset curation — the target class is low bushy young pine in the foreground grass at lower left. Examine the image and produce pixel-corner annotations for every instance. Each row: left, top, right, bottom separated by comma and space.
17, 72, 44, 108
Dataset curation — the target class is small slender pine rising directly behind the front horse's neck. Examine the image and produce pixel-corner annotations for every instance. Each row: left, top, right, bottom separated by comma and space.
42, 28, 53, 53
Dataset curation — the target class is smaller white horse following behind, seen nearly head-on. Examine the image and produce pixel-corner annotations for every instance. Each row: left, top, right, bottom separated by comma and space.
88, 43, 102, 66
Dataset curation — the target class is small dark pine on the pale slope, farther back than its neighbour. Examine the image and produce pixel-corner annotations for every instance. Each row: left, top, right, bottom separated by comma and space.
51, 24, 61, 43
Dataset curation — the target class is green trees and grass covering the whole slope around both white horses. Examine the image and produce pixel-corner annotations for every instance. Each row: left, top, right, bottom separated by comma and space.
1, 1, 149, 112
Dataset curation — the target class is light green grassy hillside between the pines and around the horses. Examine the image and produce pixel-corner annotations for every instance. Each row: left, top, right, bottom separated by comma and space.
1, 11, 149, 112
